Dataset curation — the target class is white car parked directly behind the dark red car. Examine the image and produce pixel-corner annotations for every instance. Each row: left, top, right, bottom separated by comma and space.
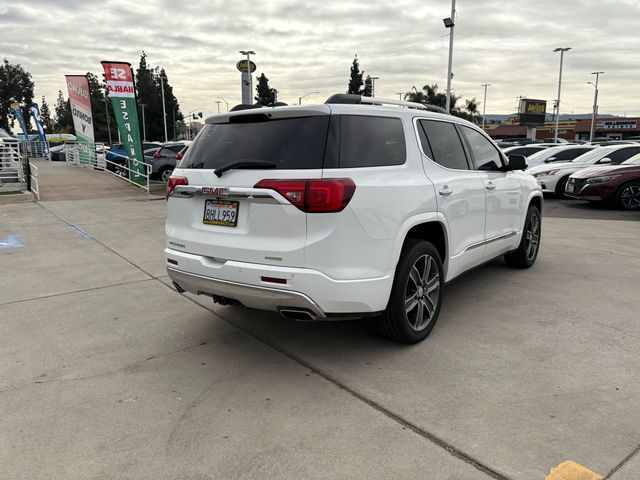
527, 143, 640, 196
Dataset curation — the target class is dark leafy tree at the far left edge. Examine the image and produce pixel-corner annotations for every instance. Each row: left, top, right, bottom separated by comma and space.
0, 58, 34, 133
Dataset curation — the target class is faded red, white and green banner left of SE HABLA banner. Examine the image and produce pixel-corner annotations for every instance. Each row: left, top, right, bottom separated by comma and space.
65, 75, 96, 165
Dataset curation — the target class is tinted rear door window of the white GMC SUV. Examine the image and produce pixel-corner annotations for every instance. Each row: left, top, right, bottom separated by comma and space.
418, 120, 469, 170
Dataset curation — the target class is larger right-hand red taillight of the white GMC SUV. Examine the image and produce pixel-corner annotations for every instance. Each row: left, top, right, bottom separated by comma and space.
254, 178, 356, 213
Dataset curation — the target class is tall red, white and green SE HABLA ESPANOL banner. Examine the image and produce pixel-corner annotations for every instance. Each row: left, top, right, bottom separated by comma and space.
101, 61, 147, 184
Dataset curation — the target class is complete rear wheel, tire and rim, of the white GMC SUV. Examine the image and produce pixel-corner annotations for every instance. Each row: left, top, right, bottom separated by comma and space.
378, 239, 444, 343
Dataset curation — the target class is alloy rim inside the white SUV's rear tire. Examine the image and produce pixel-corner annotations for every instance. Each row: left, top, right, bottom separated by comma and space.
405, 255, 440, 332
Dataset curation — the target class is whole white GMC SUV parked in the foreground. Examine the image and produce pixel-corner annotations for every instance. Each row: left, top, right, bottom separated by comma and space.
165, 94, 542, 343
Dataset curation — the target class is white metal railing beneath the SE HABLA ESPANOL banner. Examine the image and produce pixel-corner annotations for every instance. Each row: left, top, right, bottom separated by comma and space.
64, 143, 151, 193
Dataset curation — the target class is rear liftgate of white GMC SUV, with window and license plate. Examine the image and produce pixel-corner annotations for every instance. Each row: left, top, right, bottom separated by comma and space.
166, 106, 330, 267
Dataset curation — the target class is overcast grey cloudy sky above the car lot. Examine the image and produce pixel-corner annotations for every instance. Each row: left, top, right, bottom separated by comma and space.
0, 0, 640, 115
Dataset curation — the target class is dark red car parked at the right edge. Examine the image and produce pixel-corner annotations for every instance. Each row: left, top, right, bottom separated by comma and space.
565, 155, 640, 210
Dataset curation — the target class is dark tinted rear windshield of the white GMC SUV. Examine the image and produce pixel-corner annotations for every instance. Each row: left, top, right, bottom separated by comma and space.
180, 115, 329, 169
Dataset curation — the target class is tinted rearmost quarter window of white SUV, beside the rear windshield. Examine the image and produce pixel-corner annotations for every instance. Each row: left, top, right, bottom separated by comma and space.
340, 115, 407, 168
